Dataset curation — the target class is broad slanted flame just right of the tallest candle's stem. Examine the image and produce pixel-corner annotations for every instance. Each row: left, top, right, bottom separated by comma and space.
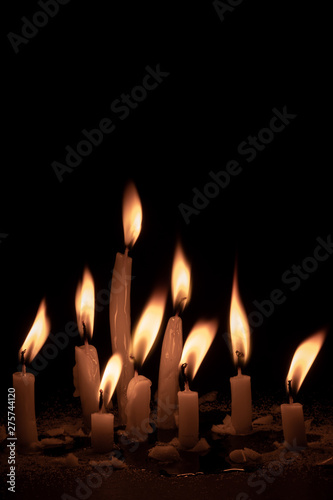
132, 292, 166, 365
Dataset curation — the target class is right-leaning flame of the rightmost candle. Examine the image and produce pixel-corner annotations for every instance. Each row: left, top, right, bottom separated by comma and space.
286, 331, 326, 394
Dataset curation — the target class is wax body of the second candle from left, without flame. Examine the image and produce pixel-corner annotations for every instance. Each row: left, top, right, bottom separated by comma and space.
73, 343, 100, 429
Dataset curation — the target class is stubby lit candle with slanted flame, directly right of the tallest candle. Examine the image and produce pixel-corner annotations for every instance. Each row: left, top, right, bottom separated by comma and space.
126, 292, 166, 441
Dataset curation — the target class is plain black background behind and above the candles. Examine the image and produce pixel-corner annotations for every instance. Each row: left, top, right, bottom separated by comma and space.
0, 0, 333, 414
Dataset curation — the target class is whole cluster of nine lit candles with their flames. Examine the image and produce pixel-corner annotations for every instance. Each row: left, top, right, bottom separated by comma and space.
13, 184, 325, 452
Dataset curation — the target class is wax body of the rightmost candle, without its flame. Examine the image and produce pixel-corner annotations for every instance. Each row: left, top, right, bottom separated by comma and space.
281, 403, 307, 448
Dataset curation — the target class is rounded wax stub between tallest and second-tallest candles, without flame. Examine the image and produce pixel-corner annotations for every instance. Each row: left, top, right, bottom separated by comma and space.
126, 372, 151, 441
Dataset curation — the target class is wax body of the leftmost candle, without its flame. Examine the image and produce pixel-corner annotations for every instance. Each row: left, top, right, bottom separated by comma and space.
13, 372, 38, 449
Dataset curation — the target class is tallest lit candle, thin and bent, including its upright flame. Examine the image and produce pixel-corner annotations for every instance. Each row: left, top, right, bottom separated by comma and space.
109, 184, 142, 424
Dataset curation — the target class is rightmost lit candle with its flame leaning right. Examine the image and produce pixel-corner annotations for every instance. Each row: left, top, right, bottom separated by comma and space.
281, 331, 326, 449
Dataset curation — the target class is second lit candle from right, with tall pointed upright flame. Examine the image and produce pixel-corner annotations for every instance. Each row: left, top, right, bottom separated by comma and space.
230, 269, 252, 434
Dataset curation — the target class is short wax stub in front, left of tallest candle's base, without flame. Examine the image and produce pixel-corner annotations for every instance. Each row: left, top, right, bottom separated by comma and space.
91, 412, 114, 453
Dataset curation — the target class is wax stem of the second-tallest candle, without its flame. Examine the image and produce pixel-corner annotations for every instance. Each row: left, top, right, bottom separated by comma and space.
157, 316, 183, 429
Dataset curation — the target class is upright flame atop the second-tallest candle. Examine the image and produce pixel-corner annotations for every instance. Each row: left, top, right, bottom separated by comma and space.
171, 244, 191, 309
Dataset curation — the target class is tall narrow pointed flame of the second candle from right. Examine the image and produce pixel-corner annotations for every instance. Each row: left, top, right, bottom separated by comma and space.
229, 270, 250, 365
